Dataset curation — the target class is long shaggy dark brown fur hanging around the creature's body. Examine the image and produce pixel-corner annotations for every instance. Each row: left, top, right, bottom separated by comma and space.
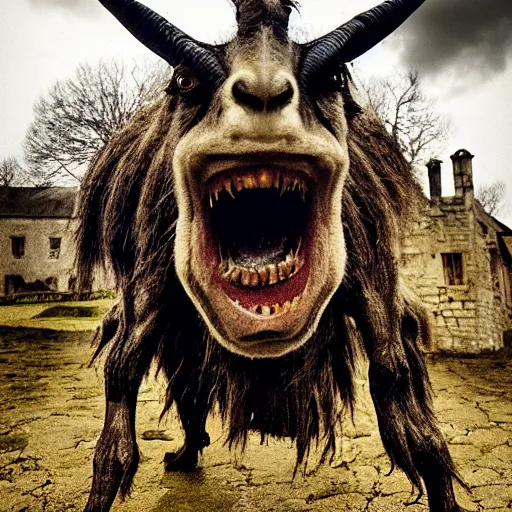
78, 88, 455, 504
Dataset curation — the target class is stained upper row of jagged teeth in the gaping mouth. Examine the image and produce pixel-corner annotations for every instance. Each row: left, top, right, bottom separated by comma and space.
210, 169, 308, 207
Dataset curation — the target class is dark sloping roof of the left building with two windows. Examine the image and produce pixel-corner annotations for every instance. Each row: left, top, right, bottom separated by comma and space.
0, 187, 78, 219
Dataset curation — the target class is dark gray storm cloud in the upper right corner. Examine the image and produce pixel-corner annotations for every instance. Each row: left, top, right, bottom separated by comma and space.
400, 0, 512, 79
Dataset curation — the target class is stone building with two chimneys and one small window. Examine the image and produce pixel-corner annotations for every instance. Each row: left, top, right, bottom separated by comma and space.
402, 150, 512, 353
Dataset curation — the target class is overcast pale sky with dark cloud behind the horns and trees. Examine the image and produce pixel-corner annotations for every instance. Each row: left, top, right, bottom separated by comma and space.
0, 0, 512, 225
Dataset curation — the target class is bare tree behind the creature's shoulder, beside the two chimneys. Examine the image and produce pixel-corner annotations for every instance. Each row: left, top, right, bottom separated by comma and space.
360, 72, 450, 164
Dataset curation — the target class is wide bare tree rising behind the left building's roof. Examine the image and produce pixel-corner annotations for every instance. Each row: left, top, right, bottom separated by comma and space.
24, 61, 165, 186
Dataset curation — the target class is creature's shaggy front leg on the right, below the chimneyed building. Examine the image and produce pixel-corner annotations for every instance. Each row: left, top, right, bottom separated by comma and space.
369, 318, 464, 512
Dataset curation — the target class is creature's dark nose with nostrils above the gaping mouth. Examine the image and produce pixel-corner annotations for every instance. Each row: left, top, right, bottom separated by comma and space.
231, 78, 294, 112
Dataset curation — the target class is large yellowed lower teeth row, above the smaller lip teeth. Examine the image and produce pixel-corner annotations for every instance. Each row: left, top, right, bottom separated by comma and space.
221, 250, 303, 288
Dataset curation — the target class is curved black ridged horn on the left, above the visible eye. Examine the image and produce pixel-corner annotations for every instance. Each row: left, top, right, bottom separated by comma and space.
99, 0, 225, 84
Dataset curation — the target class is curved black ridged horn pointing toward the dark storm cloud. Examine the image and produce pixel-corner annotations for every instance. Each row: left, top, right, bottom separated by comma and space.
301, 0, 425, 87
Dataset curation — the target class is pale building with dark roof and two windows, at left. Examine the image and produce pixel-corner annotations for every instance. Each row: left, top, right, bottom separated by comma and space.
0, 187, 111, 296
